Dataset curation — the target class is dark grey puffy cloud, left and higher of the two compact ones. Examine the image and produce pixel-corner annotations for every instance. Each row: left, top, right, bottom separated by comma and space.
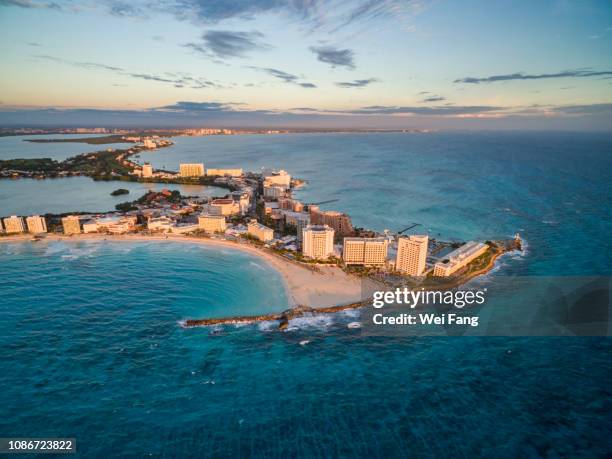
183, 30, 270, 59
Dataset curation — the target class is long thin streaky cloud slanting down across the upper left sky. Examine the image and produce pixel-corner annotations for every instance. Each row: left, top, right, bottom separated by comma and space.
32, 54, 221, 89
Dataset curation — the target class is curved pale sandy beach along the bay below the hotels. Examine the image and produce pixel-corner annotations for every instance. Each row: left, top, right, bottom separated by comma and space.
0, 234, 376, 308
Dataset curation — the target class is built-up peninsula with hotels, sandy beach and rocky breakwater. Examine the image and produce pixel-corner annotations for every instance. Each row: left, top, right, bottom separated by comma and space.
0, 155, 521, 328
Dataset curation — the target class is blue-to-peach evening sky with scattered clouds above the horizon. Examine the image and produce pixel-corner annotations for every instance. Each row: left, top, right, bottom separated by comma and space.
0, 0, 612, 131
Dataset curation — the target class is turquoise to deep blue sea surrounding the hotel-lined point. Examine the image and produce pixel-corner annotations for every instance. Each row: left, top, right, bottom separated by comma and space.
0, 133, 612, 457
